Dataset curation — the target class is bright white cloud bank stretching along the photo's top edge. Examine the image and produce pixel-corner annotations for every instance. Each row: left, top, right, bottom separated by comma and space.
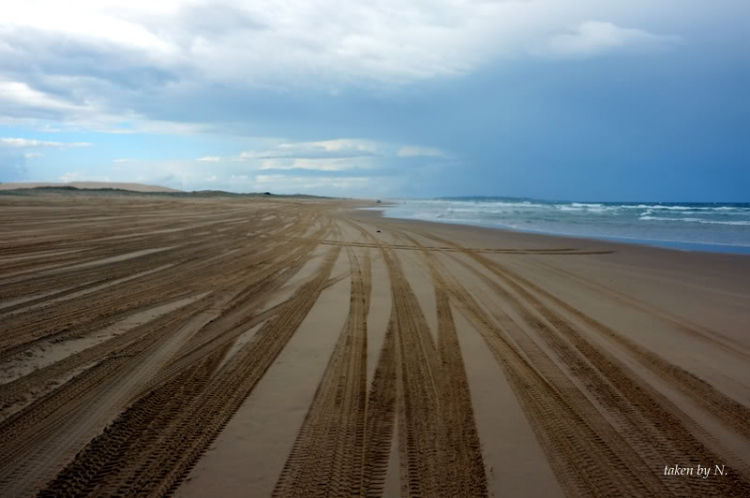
0, 0, 684, 89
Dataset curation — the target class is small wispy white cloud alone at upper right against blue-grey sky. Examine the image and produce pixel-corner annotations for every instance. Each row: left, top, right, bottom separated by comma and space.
540, 21, 681, 57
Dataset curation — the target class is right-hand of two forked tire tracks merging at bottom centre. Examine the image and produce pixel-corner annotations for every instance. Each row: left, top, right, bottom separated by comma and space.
340, 216, 494, 496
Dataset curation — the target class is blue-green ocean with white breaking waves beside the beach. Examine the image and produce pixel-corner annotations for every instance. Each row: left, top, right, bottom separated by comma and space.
378, 197, 750, 254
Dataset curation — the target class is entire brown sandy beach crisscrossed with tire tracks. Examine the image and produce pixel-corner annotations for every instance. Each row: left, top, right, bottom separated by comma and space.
0, 194, 750, 497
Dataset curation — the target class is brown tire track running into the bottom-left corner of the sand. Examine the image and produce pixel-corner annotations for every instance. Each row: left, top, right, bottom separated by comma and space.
0, 294, 225, 495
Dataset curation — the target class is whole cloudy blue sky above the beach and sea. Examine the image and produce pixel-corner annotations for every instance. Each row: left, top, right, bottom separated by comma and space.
0, 0, 750, 202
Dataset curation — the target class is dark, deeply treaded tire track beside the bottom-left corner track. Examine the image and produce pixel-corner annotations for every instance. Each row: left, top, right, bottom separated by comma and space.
35, 244, 340, 496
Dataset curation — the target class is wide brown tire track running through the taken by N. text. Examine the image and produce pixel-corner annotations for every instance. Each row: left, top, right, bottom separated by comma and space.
408, 229, 750, 496
